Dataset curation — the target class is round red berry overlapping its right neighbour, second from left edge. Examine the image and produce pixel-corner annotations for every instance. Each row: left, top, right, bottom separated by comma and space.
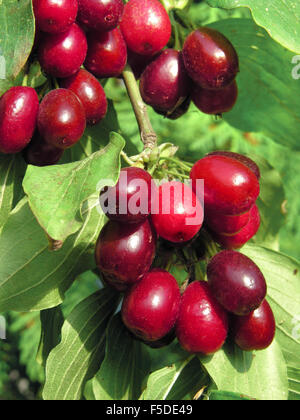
38, 89, 86, 149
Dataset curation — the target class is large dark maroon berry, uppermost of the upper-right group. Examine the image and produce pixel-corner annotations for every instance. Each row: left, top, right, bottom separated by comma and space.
182, 27, 239, 89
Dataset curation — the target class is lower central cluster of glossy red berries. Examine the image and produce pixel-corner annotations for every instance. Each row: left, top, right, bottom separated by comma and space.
95, 152, 275, 354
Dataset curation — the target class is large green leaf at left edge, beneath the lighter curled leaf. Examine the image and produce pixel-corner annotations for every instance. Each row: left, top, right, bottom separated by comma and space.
0, 199, 105, 312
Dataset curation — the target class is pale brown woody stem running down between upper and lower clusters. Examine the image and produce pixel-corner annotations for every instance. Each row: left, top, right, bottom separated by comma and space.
123, 64, 157, 149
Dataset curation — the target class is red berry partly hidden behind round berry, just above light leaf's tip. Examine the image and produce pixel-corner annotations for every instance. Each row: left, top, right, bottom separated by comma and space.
60, 69, 107, 125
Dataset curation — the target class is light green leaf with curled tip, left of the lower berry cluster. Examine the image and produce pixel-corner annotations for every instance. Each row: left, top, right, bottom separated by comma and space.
23, 133, 124, 242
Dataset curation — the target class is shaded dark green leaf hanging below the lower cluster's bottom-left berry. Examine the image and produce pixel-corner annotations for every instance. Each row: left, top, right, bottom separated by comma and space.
93, 314, 150, 400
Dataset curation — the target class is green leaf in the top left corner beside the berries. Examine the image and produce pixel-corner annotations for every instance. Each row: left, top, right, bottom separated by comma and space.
0, 0, 34, 95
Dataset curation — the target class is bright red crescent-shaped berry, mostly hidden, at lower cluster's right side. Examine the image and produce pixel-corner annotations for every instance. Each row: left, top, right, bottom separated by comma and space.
213, 204, 260, 249
